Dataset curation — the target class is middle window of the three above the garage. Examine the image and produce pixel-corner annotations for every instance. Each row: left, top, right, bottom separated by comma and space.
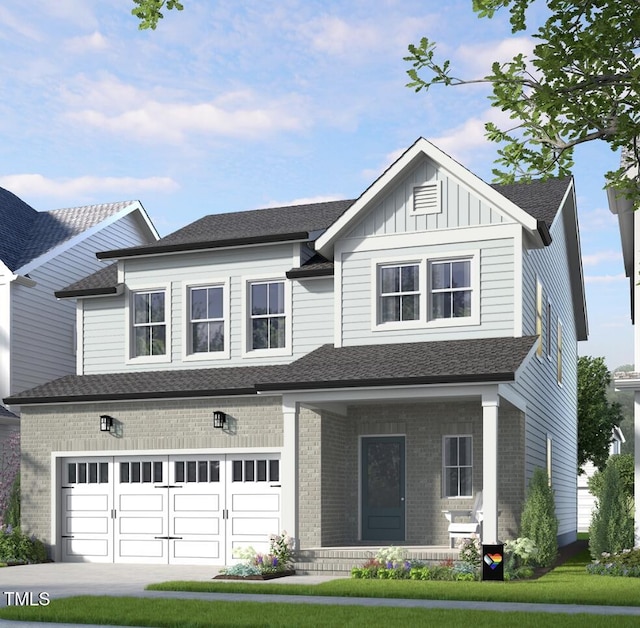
189, 286, 225, 353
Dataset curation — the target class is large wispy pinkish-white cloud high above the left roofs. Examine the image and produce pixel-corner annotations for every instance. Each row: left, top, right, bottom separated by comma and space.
66, 77, 310, 143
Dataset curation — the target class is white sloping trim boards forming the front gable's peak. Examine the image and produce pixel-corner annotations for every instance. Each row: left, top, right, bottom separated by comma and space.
316, 137, 557, 257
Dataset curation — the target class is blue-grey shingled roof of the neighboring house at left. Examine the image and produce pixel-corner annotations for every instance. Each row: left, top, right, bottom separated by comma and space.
0, 194, 157, 272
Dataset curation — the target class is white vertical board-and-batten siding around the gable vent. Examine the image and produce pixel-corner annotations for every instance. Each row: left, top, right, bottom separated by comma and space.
347, 158, 511, 238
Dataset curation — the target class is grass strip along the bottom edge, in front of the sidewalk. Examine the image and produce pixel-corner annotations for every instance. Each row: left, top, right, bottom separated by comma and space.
0, 597, 638, 628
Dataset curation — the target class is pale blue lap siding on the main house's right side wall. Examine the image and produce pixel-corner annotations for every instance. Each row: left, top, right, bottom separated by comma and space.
515, 202, 578, 542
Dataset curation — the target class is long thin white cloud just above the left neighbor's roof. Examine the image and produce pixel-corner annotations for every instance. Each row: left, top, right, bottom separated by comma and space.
0, 174, 179, 199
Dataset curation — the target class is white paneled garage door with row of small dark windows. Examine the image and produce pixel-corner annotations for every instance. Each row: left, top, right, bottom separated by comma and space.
61, 454, 281, 565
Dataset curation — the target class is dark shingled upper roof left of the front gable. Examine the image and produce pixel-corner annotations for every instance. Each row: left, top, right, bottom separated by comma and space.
98, 200, 353, 259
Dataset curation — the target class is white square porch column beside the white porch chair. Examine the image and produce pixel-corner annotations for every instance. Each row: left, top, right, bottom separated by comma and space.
482, 391, 500, 544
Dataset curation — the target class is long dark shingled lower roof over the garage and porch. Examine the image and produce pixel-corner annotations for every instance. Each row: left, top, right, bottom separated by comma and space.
5, 336, 537, 405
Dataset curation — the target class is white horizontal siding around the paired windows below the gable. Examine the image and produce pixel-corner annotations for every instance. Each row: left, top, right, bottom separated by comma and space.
341, 238, 515, 346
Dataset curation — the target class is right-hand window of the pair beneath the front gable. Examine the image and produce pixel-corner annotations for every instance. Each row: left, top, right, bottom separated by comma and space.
430, 259, 473, 320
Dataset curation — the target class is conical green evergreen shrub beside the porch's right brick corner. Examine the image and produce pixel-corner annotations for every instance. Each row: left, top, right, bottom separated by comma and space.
520, 468, 558, 567
